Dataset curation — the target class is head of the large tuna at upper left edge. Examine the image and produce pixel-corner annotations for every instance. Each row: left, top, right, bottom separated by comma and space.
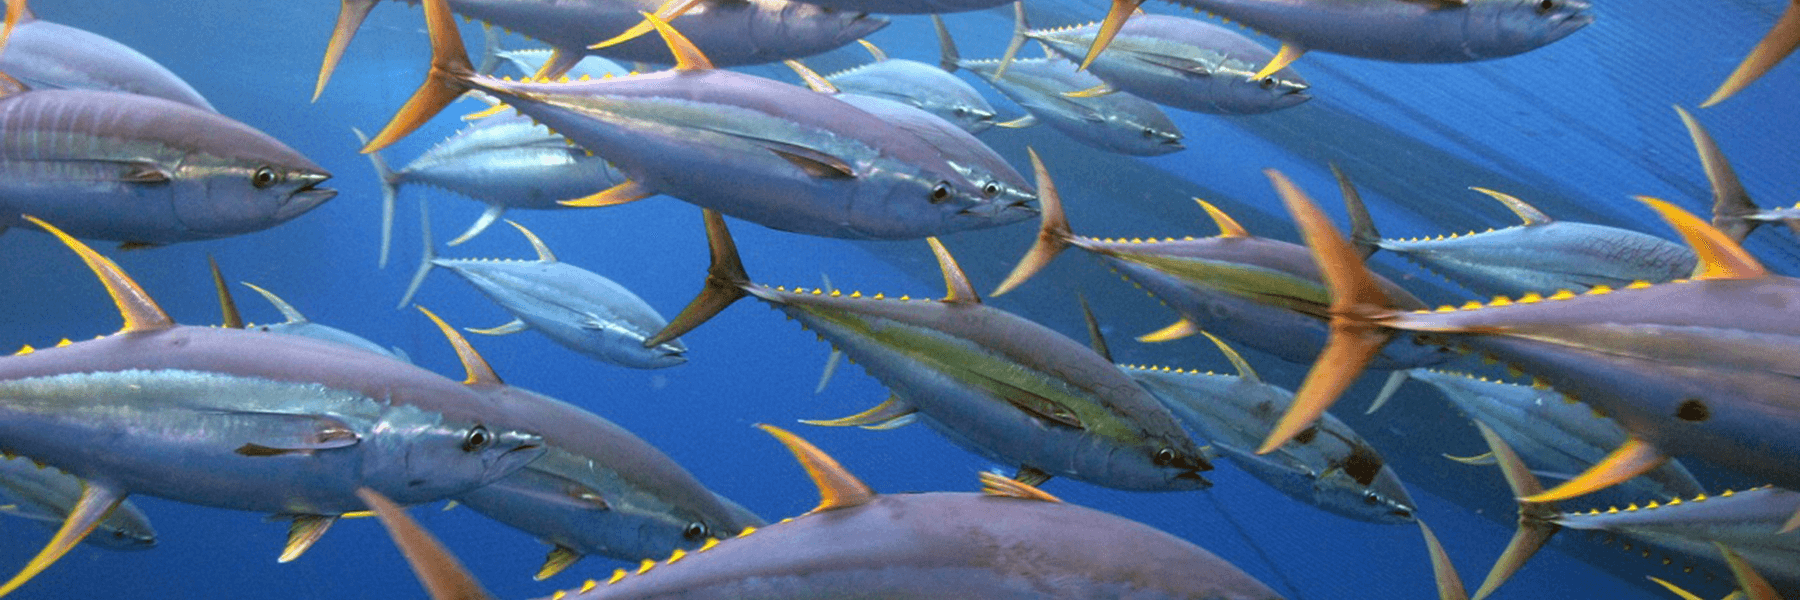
171, 117, 337, 236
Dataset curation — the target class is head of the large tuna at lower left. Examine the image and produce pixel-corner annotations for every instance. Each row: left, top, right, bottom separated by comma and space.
364, 404, 545, 503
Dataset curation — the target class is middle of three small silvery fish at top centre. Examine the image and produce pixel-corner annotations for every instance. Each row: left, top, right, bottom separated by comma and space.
932, 16, 1186, 157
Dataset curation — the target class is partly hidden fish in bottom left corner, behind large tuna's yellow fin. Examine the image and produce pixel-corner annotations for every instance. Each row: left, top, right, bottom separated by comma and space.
0, 458, 157, 551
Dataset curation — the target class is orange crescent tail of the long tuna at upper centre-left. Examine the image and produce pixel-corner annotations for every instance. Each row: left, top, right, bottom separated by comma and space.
362, 0, 475, 153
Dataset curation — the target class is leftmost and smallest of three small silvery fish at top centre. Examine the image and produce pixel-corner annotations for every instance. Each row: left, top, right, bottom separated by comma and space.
824, 40, 994, 133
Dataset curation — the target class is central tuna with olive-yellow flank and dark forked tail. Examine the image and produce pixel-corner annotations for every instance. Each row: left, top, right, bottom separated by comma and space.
650, 203, 1211, 490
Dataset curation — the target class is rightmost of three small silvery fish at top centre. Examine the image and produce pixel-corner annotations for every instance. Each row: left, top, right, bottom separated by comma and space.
1013, 2, 1312, 115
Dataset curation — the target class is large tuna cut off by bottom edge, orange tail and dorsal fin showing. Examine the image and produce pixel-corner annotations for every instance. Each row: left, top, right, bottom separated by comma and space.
364, 425, 1280, 600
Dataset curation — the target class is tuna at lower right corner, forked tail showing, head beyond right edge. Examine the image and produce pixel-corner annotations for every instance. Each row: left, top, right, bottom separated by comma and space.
1454, 419, 1800, 598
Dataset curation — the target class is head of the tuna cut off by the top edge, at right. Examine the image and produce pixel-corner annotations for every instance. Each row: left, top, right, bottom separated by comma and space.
1465, 0, 1593, 58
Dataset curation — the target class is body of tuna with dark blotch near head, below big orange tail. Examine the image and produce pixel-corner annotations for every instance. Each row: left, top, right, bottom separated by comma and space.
1123, 366, 1418, 523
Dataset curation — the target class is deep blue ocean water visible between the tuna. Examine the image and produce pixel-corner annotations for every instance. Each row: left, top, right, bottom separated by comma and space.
0, 0, 1800, 600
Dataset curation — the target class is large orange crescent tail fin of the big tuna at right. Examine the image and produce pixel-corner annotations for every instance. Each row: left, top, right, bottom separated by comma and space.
1256, 169, 1395, 454
